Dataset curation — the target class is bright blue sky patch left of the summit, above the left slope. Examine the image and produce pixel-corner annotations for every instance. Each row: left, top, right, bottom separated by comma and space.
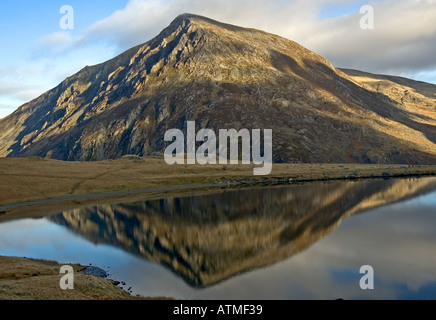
0, 0, 127, 118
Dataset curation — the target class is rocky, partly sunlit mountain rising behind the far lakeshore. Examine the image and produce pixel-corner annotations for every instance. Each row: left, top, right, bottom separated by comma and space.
0, 14, 436, 164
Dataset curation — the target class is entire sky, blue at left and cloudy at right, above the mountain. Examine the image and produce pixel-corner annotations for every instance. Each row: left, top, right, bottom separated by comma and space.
0, 0, 436, 118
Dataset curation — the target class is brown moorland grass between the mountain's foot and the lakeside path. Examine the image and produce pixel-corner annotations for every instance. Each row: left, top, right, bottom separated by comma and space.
0, 156, 436, 206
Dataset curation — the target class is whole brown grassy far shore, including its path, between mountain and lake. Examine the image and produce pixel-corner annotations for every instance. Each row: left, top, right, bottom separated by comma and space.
0, 156, 436, 222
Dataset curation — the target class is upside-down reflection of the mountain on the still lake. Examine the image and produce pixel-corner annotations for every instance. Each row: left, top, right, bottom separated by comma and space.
50, 178, 436, 287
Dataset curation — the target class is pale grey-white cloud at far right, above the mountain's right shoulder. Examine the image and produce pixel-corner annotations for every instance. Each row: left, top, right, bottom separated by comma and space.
306, 0, 436, 73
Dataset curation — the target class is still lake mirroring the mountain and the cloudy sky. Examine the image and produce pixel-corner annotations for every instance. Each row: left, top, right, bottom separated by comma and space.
0, 177, 436, 300
